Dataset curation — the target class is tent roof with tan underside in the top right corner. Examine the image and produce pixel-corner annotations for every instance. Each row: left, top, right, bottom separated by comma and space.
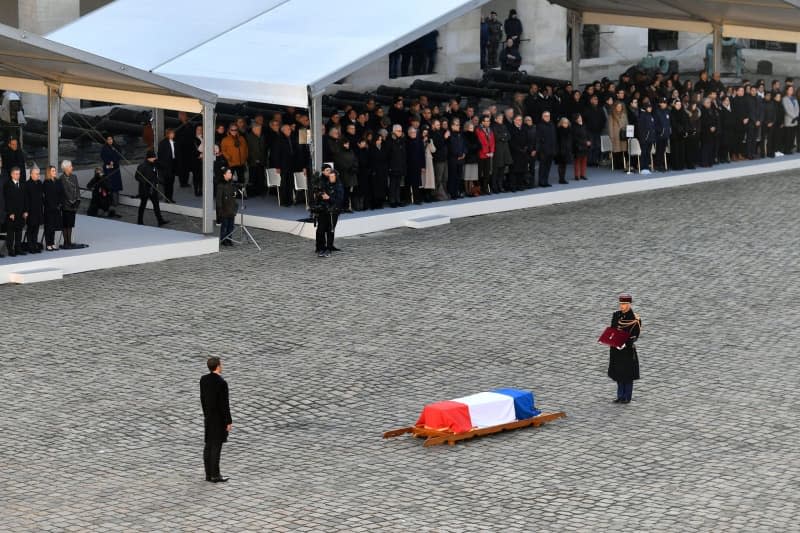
550, 0, 800, 42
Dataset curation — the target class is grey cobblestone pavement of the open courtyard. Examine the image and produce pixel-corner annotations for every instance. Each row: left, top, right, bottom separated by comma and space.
0, 174, 800, 532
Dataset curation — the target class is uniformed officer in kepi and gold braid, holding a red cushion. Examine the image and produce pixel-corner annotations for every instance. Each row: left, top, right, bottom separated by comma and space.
608, 294, 642, 403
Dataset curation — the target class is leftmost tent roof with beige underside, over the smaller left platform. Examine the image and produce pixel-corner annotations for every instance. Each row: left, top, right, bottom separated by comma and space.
0, 24, 216, 111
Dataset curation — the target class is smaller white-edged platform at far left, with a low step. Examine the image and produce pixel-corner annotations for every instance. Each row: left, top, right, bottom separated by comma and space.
0, 215, 219, 284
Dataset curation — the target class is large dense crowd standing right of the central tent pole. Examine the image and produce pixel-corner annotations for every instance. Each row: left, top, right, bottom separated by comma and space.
312, 69, 800, 210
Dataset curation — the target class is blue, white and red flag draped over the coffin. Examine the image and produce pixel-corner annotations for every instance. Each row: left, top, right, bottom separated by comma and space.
416, 389, 540, 433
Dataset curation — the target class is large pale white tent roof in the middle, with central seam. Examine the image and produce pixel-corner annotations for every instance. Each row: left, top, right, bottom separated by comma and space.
48, 0, 488, 107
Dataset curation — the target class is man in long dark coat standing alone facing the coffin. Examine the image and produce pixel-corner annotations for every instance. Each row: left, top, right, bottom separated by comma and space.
200, 357, 233, 483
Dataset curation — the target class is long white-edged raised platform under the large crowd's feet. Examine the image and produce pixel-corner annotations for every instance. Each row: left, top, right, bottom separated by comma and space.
81, 154, 800, 238
